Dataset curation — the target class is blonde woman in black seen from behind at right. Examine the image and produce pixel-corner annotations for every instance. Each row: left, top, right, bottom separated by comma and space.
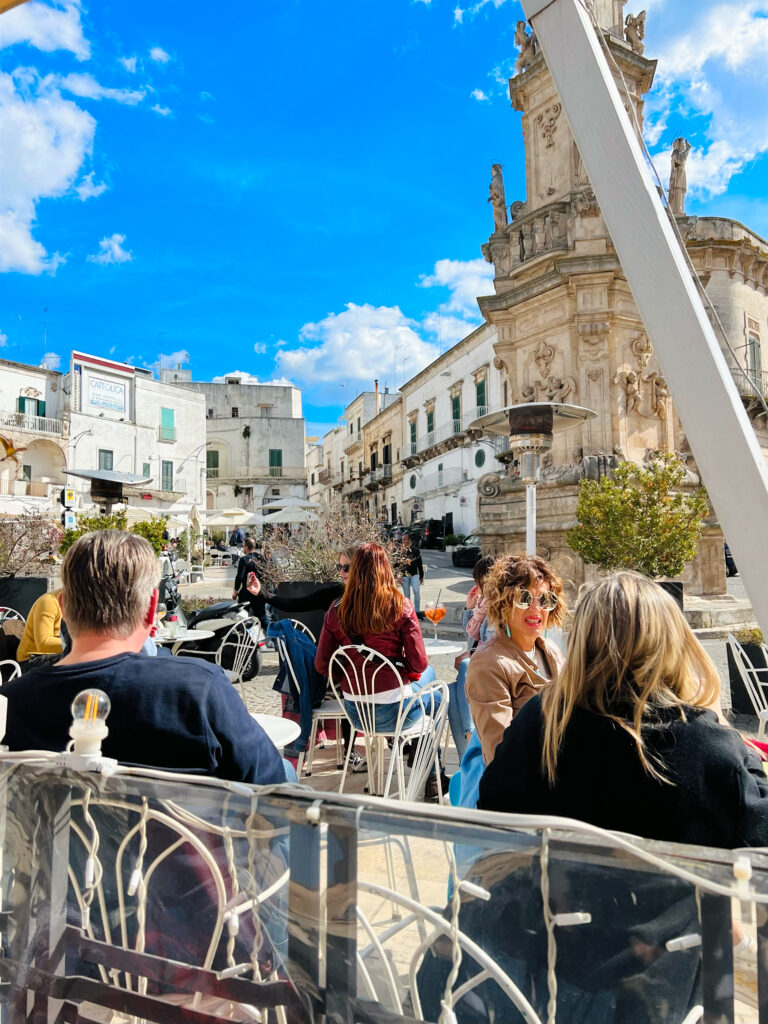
479, 572, 768, 849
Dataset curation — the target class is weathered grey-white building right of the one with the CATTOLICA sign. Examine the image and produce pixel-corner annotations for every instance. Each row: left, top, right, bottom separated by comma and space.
179, 373, 307, 511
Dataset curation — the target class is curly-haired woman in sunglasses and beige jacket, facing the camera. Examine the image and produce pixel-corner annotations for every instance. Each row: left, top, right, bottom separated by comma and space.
466, 555, 566, 765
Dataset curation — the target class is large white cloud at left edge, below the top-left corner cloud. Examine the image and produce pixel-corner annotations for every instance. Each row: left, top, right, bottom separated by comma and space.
0, 68, 96, 273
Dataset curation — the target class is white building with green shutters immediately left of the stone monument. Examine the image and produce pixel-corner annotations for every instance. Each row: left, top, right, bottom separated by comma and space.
400, 324, 503, 534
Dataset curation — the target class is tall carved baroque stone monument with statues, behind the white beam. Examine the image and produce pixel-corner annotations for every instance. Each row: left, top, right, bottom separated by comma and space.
478, 0, 725, 594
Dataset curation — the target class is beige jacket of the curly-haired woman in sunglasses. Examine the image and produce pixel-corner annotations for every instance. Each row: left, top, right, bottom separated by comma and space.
466, 630, 564, 765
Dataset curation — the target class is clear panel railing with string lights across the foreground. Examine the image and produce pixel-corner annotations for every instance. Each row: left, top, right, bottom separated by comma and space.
0, 755, 768, 1024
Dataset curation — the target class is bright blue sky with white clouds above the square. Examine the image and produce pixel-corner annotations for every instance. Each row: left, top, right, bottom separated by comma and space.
0, 0, 768, 432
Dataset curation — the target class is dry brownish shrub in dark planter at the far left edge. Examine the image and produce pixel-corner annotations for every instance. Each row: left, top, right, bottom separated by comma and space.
0, 512, 61, 616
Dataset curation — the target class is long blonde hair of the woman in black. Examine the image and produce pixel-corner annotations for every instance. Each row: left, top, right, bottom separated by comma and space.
542, 572, 720, 785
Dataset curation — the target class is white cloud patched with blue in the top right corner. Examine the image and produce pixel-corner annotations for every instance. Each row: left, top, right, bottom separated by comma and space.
645, 0, 768, 199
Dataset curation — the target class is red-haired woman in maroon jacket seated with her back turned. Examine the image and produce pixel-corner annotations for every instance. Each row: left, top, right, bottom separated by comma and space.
314, 544, 447, 798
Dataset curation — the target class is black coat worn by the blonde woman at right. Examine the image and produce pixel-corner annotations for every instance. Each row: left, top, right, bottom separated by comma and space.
477, 696, 768, 849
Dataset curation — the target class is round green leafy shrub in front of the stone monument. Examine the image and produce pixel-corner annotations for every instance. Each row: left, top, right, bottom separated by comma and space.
567, 452, 709, 608
